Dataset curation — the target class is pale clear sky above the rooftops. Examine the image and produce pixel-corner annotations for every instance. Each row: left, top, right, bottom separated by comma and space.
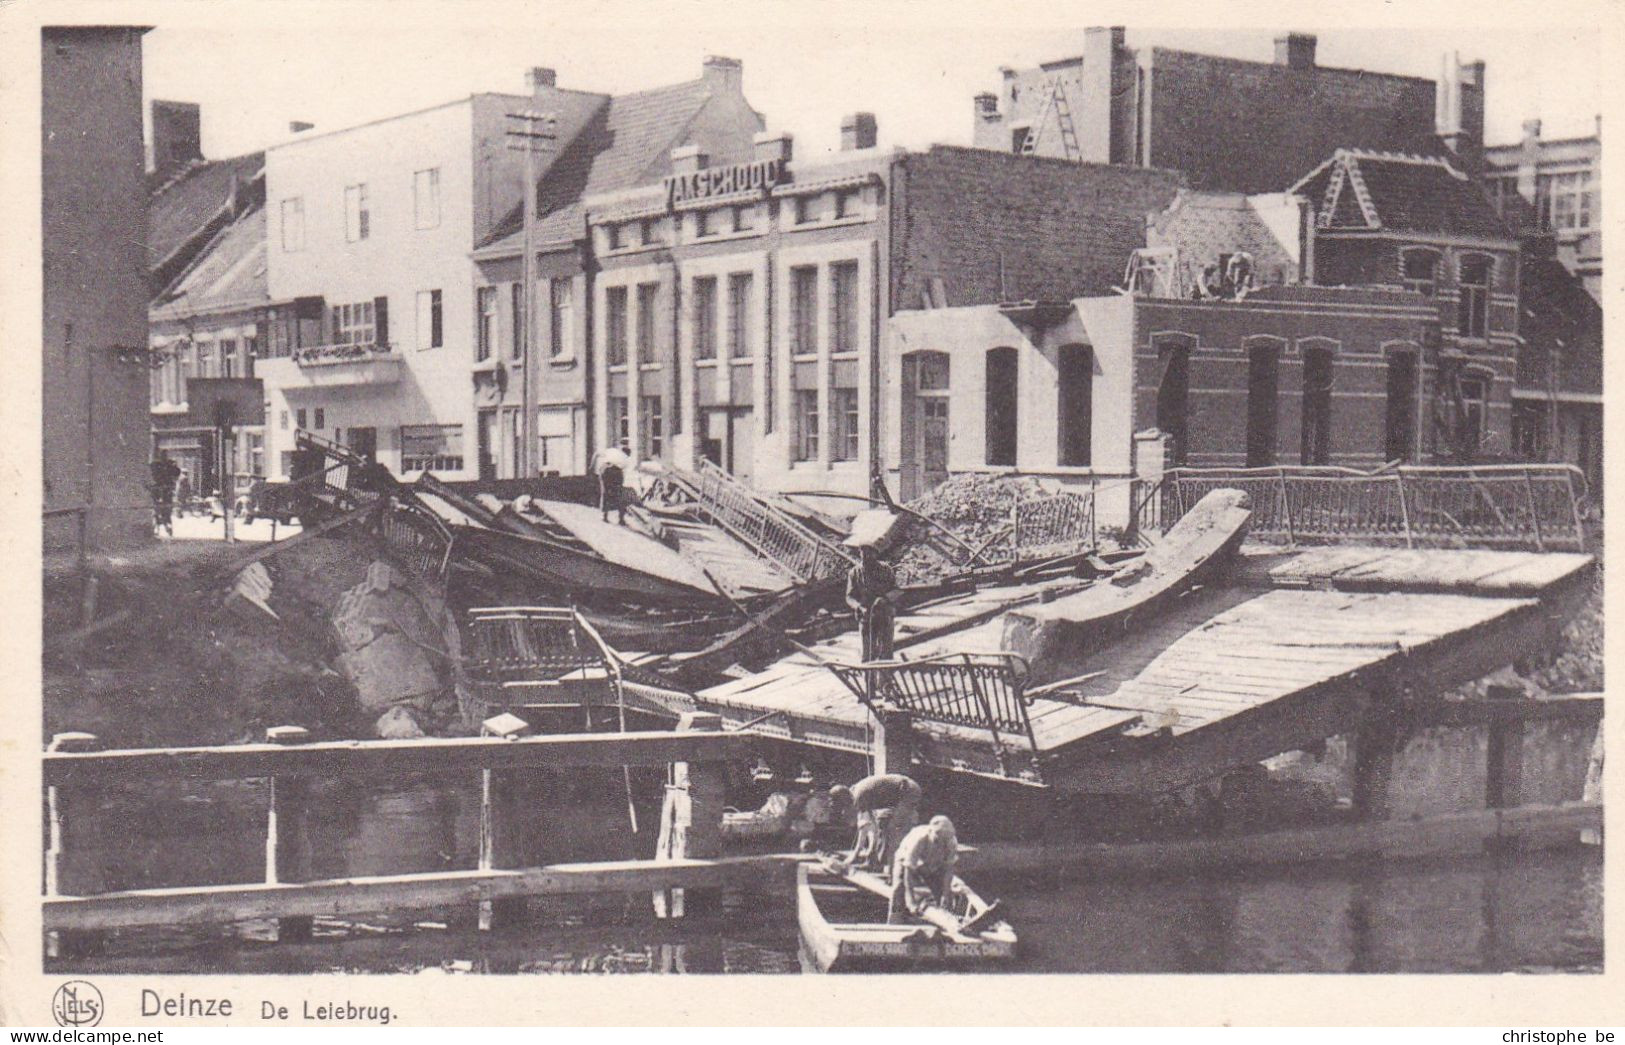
141, 0, 1617, 158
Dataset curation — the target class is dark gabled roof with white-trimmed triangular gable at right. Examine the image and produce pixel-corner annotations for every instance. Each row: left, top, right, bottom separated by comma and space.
1289, 150, 1515, 241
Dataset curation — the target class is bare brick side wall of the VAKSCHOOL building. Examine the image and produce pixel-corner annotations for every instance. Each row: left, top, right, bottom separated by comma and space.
892, 146, 1183, 309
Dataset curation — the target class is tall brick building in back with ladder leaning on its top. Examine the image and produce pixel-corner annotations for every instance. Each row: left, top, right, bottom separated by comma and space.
972, 28, 1484, 193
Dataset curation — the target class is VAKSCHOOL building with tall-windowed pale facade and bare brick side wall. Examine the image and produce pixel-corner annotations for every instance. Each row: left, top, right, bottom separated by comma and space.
587, 133, 1180, 492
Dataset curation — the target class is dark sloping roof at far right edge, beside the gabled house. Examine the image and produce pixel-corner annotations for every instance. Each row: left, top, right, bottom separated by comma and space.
1518, 241, 1602, 395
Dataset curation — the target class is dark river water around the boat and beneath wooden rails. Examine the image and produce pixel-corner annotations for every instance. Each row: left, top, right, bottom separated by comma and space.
47, 772, 1602, 973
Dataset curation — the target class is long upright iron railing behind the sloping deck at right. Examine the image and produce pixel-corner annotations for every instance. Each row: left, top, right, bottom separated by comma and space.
1160, 465, 1586, 551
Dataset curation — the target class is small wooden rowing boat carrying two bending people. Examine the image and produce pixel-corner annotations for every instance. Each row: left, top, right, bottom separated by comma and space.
796, 863, 1016, 972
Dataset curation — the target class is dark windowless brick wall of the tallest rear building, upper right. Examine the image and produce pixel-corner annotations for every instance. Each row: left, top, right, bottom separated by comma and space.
1149, 47, 1440, 192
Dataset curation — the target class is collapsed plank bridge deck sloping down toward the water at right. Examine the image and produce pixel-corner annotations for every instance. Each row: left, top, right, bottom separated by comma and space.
679, 546, 1593, 793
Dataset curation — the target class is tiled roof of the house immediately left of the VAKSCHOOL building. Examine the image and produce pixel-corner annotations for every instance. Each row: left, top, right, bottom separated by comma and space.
481, 80, 712, 249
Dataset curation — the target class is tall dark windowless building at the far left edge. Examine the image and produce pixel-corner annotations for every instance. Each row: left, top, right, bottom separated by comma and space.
41, 26, 153, 553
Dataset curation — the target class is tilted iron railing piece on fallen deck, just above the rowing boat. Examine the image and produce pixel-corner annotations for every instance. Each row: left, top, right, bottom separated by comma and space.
829, 653, 1038, 761
